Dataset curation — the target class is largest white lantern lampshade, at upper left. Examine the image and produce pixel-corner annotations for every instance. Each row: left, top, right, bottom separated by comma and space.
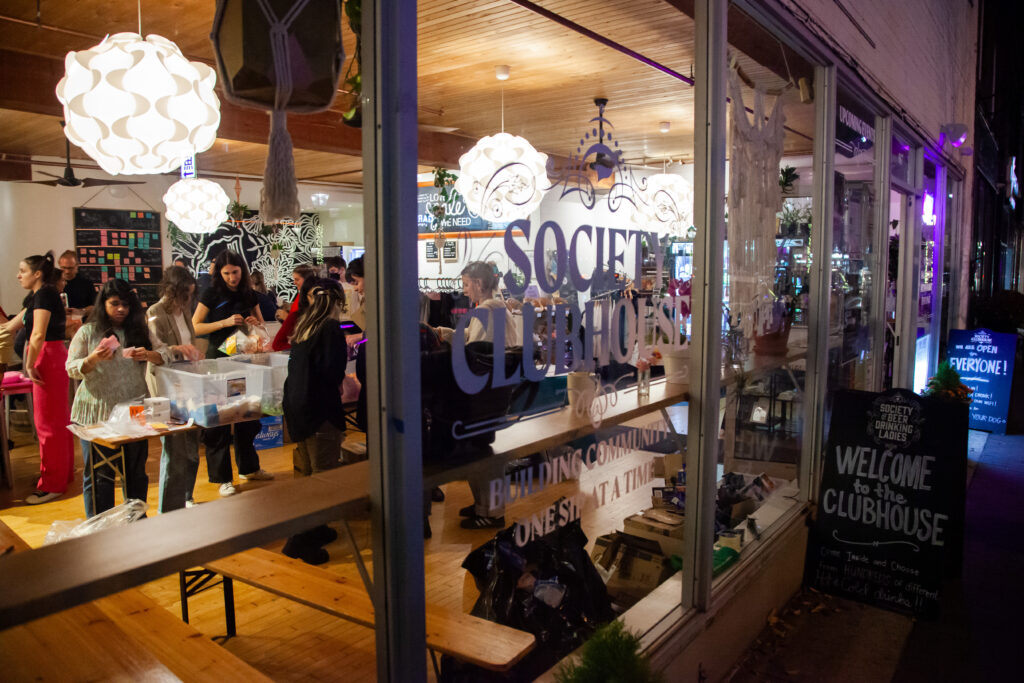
56, 33, 220, 175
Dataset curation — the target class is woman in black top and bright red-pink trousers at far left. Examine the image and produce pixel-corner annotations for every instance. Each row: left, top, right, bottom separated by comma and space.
5, 252, 75, 505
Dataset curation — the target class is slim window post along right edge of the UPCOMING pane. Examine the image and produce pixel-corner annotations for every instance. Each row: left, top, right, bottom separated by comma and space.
868, 117, 892, 391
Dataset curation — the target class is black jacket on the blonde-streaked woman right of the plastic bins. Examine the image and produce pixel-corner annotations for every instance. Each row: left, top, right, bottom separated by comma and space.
285, 323, 348, 441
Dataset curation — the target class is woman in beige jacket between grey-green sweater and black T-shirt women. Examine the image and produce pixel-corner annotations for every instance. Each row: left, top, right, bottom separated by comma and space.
145, 265, 202, 513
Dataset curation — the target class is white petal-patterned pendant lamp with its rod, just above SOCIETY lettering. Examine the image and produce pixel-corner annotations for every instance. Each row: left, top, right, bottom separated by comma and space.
455, 65, 548, 223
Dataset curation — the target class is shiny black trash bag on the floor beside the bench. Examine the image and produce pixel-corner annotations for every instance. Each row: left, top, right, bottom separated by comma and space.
441, 516, 615, 682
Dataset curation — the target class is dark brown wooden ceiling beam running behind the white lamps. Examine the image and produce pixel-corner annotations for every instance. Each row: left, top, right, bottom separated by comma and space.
0, 49, 476, 168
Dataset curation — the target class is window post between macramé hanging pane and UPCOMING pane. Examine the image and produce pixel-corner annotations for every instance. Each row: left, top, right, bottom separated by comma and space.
800, 67, 836, 500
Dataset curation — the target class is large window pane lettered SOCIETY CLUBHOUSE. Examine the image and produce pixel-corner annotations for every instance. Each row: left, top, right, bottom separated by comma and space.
415, 0, 694, 680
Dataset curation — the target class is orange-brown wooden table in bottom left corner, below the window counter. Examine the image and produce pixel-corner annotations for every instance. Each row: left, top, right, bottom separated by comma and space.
0, 522, 270, 681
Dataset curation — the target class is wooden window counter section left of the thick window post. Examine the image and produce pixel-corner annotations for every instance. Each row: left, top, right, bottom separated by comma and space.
0, 462, 370, 629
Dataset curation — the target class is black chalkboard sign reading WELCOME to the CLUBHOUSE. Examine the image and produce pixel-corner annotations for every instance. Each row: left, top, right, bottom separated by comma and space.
805, 389, 967, 618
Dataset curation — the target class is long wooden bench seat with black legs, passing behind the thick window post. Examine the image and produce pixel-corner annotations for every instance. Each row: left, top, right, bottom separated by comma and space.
195, 548, 535, 671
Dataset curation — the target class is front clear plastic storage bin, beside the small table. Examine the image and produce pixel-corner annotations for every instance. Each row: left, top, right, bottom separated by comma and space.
156, 358, 269, 427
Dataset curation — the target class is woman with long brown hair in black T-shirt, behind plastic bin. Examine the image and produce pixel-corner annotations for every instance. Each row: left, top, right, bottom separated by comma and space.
193, 251, 273, 496
